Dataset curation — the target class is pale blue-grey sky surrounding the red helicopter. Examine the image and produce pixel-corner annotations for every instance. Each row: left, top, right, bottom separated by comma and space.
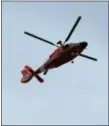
2, 2, 108, 125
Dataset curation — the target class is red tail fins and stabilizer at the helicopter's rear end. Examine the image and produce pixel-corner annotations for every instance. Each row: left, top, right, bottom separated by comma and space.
21, 66, 44, 83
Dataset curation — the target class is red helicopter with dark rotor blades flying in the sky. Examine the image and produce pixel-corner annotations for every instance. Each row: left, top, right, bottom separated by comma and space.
21, 16, 97, 84
